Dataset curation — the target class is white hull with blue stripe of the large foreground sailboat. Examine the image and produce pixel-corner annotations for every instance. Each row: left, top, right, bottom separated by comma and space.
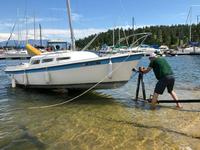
7, 54, 142, 89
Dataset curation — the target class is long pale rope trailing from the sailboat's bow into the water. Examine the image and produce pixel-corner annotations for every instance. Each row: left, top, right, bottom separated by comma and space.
7, 53, 136, 111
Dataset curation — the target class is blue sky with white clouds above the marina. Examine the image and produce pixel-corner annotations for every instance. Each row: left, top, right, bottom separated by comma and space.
0, 0, 200, 41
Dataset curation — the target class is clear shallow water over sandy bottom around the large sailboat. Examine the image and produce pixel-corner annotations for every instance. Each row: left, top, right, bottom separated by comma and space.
0, 56, 200, 150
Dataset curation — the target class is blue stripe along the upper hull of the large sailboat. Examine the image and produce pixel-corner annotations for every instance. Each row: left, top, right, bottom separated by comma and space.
6, 54, 143, 74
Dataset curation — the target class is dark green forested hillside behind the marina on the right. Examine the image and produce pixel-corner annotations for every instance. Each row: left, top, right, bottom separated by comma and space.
76, 24, 200, 50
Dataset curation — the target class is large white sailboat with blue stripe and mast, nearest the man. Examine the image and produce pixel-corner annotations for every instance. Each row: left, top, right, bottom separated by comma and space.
5, 0, 143, 89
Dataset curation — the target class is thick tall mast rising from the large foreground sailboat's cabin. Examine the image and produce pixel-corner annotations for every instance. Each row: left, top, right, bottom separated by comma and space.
66, 0, 76, 51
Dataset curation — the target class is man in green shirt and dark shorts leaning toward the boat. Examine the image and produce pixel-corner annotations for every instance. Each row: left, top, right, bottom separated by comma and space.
140, 53, 182, 108
